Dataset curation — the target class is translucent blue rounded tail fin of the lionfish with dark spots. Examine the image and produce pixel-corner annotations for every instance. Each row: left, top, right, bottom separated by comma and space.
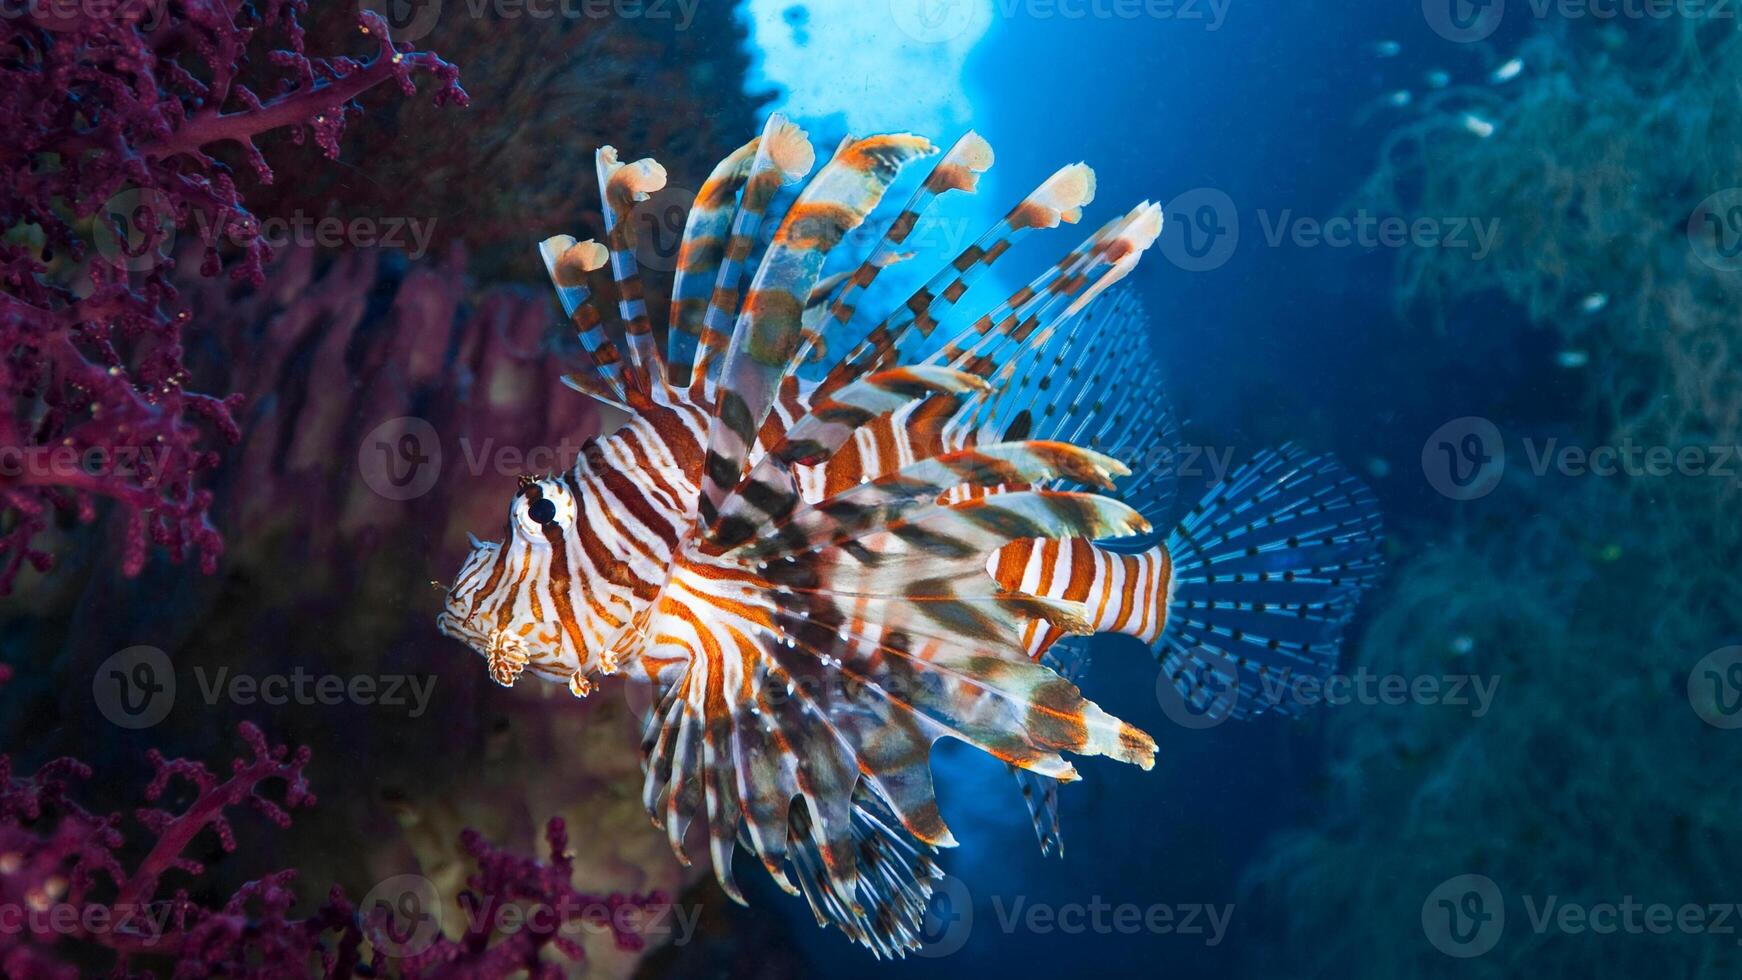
1160, 444, 1383, 717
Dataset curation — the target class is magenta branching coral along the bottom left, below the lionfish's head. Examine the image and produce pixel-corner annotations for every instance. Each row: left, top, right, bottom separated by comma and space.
0, 710, 665, 980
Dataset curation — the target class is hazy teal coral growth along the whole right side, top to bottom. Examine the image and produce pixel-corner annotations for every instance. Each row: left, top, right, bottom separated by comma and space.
1247, 17, 1742, 977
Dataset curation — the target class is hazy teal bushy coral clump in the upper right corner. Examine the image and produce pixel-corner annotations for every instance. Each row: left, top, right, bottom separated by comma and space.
1361, 17, 1742, 444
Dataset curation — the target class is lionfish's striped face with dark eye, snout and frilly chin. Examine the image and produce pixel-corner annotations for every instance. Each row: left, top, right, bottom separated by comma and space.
436, 480, 580, 688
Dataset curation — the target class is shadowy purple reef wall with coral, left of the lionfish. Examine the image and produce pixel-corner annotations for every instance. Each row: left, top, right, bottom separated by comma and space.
0, 0, 758, 977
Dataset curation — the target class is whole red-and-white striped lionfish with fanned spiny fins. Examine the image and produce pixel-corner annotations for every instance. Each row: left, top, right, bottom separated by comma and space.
439, 115, 1380, 956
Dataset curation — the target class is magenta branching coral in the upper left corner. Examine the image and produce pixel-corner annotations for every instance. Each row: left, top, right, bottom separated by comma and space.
0, 0, 467, 594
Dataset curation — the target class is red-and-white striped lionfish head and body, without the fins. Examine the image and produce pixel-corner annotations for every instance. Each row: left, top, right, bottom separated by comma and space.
441, 379, 1171, 693
